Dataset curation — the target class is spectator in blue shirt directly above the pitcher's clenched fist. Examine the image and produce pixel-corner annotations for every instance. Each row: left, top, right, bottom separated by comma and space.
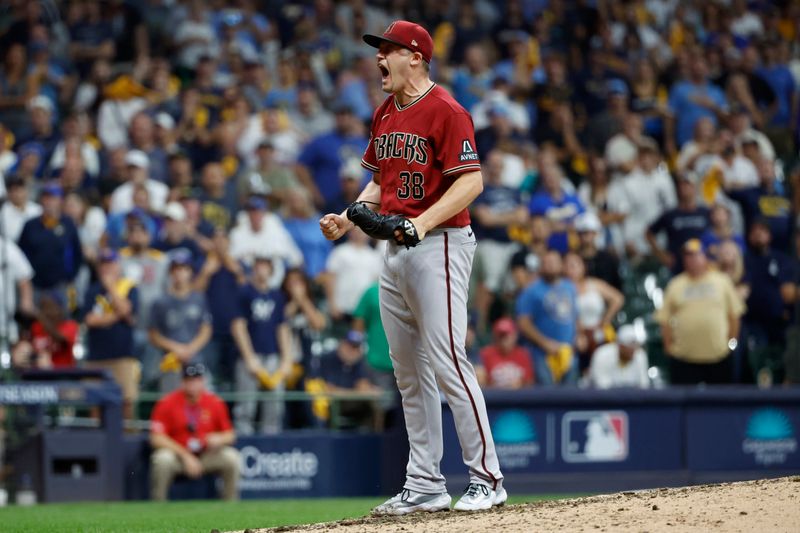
297, 103, 368, 207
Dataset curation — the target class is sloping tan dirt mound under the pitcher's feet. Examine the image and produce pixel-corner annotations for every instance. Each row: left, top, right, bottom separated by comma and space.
238, 476, 800, 533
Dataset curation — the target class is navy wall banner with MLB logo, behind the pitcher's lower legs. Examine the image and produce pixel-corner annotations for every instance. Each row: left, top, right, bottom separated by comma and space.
442, 405, 683, 475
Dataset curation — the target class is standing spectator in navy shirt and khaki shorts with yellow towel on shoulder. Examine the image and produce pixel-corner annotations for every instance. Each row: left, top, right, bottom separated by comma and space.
83, 248, 141, 420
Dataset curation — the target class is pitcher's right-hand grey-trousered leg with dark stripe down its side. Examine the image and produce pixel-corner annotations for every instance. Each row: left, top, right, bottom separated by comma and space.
408, 229, 505, 506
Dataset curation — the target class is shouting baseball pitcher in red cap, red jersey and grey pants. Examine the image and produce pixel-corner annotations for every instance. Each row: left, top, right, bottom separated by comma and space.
320, 20, 508, 515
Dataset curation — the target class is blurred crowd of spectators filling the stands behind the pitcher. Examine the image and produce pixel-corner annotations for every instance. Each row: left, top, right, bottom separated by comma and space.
0, 0, 800, 434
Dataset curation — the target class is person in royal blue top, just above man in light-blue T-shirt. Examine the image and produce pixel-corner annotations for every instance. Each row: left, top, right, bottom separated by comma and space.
528, 159, 585, 254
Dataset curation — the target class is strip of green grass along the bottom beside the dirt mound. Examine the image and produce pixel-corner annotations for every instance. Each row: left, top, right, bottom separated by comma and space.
0, 495, 563, 533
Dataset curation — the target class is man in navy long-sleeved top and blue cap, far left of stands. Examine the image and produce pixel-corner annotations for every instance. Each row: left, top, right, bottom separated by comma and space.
18, 183, 83, 296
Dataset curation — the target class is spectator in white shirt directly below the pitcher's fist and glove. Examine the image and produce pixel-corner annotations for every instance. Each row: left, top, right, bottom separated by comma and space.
322, 227, 383, 320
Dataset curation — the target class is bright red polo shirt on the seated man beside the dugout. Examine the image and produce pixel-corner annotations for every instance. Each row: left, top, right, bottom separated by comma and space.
150, 389, 232, 448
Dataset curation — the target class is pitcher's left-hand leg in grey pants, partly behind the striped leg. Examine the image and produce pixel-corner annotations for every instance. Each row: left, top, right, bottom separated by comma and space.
373, 256, 451, 514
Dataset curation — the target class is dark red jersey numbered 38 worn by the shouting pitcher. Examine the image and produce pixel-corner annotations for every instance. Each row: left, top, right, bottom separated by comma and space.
361, 84, 481, 227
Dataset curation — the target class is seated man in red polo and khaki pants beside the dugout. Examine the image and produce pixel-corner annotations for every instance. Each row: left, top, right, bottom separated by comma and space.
150, 363, 239, 501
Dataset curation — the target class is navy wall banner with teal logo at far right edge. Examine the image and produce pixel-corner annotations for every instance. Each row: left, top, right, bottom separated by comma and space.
686, 404, 800, 470
